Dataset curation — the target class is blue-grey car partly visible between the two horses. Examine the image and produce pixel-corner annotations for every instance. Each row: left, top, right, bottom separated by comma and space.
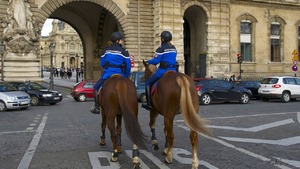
130, 72, 146, 103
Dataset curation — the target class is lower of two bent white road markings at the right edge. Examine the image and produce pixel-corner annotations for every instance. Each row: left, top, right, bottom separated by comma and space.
220, 136, 300, 146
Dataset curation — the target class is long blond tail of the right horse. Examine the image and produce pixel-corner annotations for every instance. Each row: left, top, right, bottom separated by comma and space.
176, 76, 211, 136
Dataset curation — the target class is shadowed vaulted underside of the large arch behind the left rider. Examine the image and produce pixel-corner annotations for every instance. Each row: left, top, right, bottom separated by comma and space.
41, 1, 125, 80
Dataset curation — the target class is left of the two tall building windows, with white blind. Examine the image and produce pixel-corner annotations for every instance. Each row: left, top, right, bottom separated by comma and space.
240, 20, 252, 61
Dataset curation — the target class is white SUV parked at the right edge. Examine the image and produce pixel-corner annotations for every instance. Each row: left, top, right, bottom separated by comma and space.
258, 76, 300, 103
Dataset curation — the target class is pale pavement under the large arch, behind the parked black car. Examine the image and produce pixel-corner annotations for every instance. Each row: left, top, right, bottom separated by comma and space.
43, 71, 82, 89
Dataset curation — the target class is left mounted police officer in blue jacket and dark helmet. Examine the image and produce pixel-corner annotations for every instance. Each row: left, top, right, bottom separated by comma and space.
90, 32, 131, 114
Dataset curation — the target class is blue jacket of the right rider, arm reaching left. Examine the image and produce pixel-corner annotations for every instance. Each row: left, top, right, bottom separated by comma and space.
147, 42, 177, 77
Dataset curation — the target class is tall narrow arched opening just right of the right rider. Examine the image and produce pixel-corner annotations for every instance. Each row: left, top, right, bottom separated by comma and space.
183, 5, 207, 77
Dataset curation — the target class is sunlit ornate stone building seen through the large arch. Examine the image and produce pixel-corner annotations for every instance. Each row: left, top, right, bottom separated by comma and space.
40, 20, 84, 69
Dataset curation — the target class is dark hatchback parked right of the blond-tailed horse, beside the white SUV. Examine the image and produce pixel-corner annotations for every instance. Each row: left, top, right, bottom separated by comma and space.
194, 78, 252, 105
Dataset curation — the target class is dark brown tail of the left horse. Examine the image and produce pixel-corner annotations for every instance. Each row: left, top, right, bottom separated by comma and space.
116, 80, 146, 149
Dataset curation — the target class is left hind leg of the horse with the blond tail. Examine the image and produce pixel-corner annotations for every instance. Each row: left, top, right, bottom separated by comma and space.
164, 116, 174, 164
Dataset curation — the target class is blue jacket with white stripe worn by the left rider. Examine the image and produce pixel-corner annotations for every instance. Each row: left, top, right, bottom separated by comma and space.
100, 43, 131, 79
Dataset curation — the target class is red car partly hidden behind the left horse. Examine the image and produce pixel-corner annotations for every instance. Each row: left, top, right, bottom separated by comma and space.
70, 81, 96, 102
